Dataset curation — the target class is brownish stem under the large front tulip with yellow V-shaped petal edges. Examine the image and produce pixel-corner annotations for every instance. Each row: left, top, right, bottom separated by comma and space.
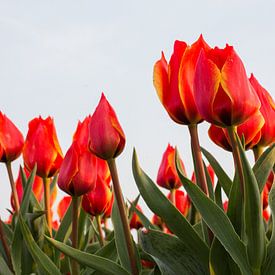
226, 126, 244, 196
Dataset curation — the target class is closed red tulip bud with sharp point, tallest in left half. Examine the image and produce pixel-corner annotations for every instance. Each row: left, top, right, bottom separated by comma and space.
89, 94, 125, 160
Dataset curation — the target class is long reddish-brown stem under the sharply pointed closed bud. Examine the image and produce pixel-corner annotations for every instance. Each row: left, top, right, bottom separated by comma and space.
107, 158, 138, 275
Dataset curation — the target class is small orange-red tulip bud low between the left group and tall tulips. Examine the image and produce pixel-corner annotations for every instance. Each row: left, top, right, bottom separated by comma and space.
157, 144, 188, 190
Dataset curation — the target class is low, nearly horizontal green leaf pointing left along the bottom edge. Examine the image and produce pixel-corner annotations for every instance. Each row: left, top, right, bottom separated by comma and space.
45, 236, 130, 275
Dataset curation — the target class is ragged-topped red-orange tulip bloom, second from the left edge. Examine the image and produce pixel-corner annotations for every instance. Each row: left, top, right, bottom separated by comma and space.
23, 117, 63, 178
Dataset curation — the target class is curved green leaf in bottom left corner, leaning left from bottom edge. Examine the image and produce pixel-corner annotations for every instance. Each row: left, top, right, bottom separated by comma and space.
19, 215, 61, 274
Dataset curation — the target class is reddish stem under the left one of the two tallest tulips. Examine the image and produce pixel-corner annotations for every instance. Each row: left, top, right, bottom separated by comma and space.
188, 124, 208, 196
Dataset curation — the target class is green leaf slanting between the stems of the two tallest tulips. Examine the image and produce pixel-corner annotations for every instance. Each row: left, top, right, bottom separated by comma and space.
201, 148, 232, 198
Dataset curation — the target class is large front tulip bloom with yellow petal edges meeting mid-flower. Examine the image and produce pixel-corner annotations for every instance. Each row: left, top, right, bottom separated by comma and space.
194, 45, 261, 127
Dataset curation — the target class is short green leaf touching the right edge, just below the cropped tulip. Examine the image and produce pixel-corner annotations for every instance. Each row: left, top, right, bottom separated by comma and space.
253, 144, 275, 193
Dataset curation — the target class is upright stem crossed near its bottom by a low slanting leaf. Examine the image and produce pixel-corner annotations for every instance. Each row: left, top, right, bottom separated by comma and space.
71, 196, 80, 275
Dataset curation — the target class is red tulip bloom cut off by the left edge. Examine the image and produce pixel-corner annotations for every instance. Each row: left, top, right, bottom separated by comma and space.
0, 112, 24, 162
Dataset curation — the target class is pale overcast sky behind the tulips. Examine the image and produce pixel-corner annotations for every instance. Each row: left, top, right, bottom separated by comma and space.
0, 0, 275, 220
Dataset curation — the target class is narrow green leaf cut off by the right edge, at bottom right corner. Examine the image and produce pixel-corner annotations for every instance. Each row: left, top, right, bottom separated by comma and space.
262, 184, 275, 274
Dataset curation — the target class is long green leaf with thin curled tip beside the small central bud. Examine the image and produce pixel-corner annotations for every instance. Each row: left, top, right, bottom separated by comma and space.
176, 152, 251, 274
